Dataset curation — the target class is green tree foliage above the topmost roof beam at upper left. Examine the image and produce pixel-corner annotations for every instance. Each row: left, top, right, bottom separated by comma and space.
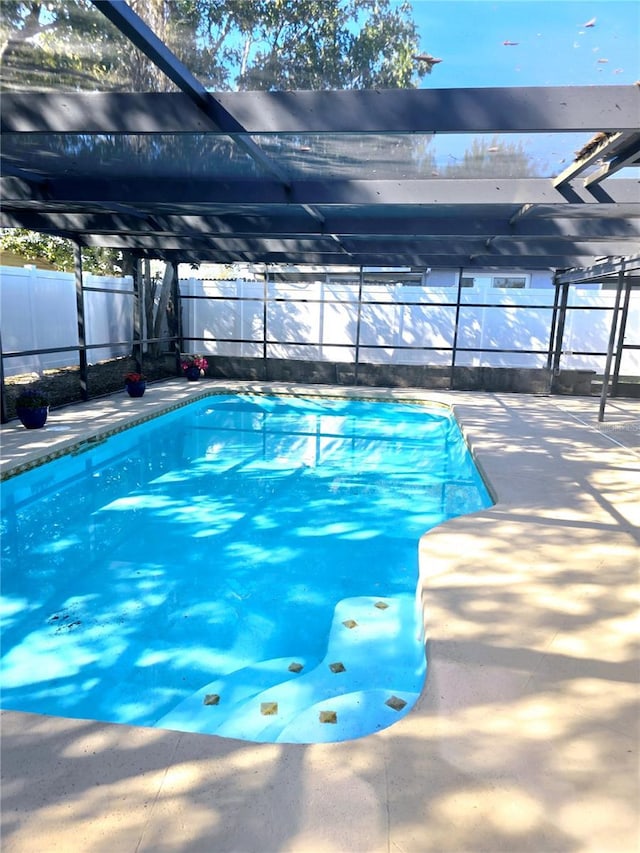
0, 0, 430, 92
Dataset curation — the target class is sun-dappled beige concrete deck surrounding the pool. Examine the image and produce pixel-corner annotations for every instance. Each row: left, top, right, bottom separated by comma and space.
1, 380, 640, 853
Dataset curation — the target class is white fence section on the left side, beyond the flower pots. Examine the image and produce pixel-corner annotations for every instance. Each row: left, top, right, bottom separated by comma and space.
0, 267, 133, 376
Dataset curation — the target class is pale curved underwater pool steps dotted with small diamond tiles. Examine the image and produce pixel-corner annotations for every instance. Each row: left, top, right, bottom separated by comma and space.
156, 596, 425, 743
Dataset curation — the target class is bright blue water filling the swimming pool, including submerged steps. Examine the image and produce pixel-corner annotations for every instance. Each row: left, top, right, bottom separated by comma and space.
1, 395, 491, 742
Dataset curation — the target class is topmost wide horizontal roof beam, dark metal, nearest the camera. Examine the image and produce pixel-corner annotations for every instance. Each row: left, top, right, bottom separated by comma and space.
0, 86, 640, 135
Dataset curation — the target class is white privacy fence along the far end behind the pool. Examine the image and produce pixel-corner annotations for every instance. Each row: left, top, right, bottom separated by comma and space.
180, 276, 640, 375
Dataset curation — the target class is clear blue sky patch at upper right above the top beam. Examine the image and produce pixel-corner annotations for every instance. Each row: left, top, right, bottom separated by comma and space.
404, 0, 640, 88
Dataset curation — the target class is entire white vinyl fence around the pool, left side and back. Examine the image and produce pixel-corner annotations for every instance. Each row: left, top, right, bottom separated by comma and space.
0, 267, 640, 376
